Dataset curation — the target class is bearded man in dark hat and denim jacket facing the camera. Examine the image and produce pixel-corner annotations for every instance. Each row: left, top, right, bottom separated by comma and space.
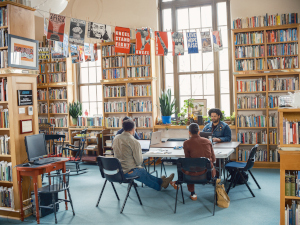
203, 109, 231, 142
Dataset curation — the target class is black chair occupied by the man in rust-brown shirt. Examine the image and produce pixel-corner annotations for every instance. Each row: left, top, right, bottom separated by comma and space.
174, 157, 217, 216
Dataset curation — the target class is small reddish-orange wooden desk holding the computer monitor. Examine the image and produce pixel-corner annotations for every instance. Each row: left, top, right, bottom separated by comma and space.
16, 158, 68, 224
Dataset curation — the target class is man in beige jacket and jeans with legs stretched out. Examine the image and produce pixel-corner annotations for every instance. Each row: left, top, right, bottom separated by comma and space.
112, 119, 174, 191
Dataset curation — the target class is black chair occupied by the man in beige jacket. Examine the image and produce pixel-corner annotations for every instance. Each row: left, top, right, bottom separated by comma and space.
96, 156, 143, 213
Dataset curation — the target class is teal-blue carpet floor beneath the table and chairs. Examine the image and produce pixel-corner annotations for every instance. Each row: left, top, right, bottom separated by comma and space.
0, 164, 280, 225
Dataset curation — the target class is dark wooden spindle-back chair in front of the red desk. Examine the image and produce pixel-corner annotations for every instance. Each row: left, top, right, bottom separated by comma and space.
38, 170, 75, 223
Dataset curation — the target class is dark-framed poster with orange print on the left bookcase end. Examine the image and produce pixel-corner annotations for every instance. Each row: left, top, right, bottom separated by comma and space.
8, 34, 39, 70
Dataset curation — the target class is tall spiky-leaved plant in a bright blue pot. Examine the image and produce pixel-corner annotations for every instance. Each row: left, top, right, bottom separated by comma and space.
159, 89, 177, 124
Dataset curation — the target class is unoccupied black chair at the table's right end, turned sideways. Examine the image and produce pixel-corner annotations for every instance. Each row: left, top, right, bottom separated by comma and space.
225, 145, 261, 197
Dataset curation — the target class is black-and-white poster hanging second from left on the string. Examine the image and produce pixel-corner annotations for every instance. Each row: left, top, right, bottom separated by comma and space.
69, 18, 85, 46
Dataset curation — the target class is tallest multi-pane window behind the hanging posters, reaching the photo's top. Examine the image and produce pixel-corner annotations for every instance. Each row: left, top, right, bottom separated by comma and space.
161, 0, 231, 116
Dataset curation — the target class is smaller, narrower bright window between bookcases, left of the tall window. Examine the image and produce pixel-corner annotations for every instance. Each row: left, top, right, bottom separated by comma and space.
79, 50, 103, 116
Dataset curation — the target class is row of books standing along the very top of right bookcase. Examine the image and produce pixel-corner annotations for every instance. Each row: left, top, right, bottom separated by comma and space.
233, 13, 299, 29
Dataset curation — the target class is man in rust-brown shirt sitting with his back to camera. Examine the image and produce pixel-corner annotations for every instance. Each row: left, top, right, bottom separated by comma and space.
183, 123, 216, 201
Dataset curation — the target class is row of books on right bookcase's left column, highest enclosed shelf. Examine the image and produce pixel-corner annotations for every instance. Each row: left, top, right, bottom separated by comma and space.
234, 31, 264, 45
